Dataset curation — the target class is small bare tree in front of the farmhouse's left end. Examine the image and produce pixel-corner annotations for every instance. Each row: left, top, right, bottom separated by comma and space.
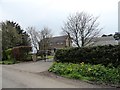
40, 27, 52, 50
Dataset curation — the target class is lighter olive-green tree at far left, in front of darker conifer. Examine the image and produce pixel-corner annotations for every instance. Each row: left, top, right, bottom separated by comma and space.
2, 22, 22, 50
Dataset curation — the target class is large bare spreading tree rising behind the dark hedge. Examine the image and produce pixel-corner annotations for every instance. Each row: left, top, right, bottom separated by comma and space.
62, 12, 101, 47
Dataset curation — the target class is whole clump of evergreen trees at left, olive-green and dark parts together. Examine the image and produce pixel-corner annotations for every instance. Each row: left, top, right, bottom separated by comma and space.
1, 21, 29, 50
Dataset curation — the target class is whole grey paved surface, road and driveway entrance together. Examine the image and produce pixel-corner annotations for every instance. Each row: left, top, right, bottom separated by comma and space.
2, 60, 112, 88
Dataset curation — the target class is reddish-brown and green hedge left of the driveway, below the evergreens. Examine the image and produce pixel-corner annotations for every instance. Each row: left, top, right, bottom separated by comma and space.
2, 46, 32, 61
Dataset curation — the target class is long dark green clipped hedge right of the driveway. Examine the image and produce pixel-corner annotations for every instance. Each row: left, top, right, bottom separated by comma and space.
55, 45, 120, 66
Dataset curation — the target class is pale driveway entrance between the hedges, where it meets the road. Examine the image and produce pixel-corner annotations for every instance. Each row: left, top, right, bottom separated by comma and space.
3, 60, 53, 73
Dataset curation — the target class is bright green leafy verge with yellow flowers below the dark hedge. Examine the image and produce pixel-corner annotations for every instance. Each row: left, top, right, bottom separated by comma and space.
49, 62, 120, 85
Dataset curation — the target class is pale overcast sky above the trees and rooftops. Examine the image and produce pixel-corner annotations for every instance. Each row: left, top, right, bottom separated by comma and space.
0, 0, 119, 36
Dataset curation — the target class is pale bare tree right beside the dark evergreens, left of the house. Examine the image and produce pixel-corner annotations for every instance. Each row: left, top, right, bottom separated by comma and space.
27, 27, 41, 50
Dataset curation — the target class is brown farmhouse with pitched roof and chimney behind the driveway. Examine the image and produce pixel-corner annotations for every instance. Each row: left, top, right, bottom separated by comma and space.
39, 35, 72, 50
